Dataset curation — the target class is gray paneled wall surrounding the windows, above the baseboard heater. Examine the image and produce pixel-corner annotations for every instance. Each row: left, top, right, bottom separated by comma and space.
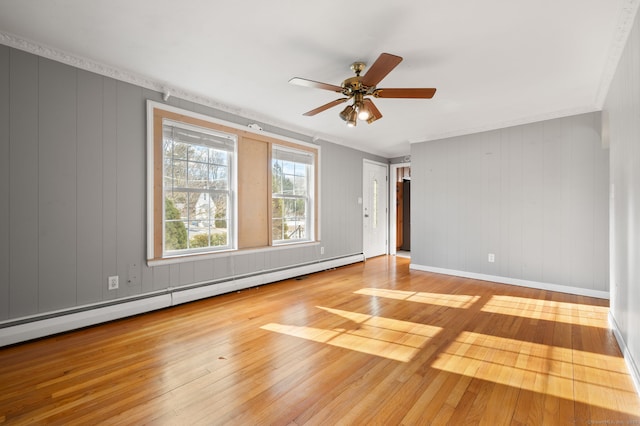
0, 46, 384, 321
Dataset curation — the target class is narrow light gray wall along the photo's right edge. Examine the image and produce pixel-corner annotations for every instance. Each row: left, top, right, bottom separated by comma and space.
604, 7, 640, 386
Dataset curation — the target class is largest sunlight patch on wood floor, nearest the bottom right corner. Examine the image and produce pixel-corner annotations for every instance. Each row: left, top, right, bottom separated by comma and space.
432, 331, 640, 414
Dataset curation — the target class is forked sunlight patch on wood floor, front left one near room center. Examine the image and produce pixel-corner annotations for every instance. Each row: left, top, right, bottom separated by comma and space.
260, 306, 441, 362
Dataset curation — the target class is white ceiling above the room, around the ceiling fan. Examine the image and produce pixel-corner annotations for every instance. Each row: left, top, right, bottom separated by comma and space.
0, 0, 639, 157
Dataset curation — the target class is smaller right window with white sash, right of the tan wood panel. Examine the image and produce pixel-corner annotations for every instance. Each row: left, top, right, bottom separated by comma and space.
271, 145, 315, 245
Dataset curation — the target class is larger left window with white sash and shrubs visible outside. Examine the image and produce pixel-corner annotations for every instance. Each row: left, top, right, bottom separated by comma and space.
162, 119, 236, 257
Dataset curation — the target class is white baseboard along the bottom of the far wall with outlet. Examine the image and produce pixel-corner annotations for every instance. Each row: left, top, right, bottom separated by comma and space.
409, 263, 610, 300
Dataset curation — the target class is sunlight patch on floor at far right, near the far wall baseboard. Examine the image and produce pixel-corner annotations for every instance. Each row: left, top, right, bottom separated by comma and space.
482, 296, 609, 328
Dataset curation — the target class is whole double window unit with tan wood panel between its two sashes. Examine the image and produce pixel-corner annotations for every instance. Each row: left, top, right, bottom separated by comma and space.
147, 100, 320, 266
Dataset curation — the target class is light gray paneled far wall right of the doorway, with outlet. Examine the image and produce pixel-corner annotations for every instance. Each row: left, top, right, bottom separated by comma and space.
411, 113, 609, 291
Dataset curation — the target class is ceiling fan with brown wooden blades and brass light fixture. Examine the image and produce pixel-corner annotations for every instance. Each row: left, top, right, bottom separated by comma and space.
289, 53, 436, 127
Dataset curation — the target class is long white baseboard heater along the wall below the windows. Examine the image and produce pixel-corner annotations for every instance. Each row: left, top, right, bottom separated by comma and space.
0, 253, 364, 347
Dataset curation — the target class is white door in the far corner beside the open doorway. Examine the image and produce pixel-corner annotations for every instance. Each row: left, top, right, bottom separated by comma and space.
362, 160, 388, 258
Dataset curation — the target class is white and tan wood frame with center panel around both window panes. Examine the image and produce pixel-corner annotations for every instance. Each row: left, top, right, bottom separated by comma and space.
146, 99, 321, 266
